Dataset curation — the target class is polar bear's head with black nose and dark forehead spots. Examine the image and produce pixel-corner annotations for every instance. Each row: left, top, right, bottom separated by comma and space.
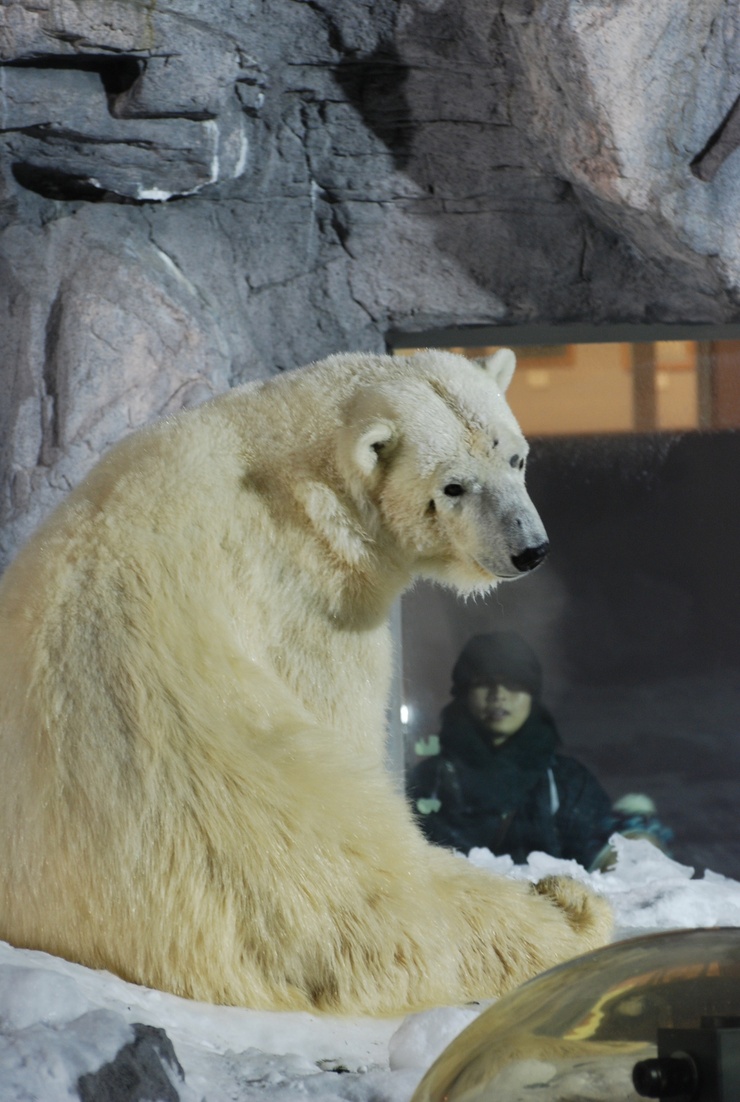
341, 349, 548, 593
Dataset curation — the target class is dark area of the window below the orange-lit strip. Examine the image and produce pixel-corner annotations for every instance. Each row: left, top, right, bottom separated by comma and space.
403, 432, 740, 877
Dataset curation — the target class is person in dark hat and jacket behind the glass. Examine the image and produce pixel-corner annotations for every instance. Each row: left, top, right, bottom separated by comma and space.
407, 631, 611, 868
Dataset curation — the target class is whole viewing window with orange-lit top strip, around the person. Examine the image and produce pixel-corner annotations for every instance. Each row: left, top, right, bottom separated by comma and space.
396, 341, 740, 878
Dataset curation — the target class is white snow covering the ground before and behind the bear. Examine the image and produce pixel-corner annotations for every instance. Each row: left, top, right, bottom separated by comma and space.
0, 839, 740, 1102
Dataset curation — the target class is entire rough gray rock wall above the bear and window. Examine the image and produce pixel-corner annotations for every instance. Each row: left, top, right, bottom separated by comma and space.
0, 0, 740, 565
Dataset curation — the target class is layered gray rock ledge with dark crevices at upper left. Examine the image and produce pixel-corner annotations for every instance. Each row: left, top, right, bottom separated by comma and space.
0, 3, 254, 201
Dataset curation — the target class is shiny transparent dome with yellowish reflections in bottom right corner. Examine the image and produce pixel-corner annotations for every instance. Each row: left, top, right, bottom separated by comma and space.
412, 928, 740, 1102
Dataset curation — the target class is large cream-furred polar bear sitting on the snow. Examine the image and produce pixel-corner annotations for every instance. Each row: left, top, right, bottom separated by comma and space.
0, 350, 610, 1015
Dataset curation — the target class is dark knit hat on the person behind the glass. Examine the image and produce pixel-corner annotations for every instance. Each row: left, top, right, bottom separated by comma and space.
453, 631, 542, 698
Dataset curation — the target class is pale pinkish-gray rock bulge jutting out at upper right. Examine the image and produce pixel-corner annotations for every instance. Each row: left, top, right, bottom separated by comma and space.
506, 0, 740, 321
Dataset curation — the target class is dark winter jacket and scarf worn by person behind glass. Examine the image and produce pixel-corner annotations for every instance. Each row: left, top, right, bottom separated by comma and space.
407, 699, 611, 868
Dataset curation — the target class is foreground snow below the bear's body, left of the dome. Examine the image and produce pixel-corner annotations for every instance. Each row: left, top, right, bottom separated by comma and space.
0, 942, 409, 1102
